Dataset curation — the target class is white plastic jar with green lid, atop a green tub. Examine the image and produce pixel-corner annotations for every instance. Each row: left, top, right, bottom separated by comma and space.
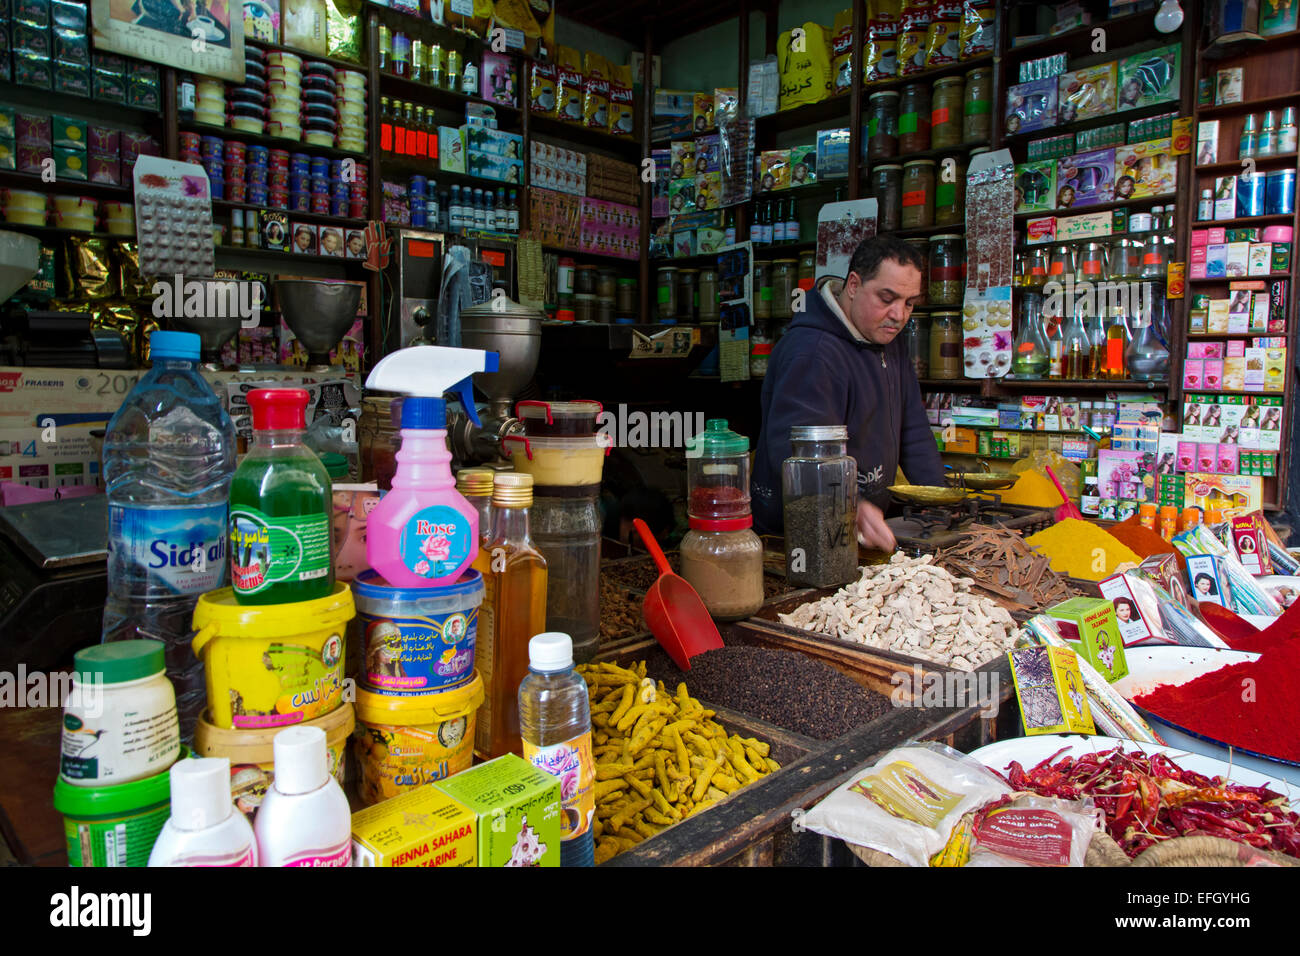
59, 640, 181, 787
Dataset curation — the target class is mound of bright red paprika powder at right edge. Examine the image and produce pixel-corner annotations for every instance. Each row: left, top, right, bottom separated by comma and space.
1134, 601, 1300, 761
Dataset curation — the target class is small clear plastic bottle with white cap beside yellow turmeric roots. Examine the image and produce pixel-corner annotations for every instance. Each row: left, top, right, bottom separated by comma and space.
519, 631, 595, 866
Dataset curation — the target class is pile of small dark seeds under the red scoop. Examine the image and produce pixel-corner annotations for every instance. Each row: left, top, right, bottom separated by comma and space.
646, 644, 892, 740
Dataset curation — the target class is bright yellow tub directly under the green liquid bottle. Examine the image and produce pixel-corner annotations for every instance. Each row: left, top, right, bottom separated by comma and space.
191, 581, 356, 730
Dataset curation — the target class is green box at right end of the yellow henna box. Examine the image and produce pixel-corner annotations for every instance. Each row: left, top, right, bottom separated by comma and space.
430, 753, 562, 866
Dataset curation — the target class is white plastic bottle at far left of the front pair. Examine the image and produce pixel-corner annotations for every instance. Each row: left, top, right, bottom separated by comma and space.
150, 757, 257, 866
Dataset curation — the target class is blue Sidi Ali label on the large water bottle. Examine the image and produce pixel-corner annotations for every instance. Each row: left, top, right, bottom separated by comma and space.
108, 505, 226, 594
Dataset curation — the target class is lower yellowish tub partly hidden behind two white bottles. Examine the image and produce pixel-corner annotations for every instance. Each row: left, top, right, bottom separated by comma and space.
194, 702, 356, 823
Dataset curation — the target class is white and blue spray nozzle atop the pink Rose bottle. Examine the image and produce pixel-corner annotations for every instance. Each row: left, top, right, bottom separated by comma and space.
365, 345, 499, 428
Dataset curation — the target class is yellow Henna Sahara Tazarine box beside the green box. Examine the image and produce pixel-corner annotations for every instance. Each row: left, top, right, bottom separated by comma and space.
352, 787, 478, 866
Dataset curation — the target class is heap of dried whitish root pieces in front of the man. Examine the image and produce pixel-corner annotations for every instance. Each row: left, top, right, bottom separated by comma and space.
780, 553, 1019, 671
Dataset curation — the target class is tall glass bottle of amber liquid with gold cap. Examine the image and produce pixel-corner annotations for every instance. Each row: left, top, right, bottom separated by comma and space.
475, 472, 546, 760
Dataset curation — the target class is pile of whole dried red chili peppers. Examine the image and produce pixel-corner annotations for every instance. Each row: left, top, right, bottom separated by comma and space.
1005, 747, 1300, 857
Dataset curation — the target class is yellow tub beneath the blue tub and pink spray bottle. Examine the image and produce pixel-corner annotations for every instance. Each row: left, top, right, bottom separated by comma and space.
354, 671, 484, 806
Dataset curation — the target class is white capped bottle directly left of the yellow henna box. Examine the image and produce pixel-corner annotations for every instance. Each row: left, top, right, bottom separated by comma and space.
254, 727, 352, 866
